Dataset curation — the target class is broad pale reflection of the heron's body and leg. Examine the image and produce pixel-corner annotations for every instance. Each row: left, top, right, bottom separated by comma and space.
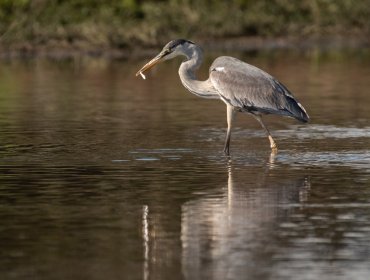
181, 164, 310, 279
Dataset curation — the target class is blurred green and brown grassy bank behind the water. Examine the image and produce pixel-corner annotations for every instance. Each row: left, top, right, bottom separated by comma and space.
0, 0, 370, 56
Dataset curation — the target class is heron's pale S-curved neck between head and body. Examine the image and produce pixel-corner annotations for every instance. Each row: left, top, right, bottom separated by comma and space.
179, 45, 220, 99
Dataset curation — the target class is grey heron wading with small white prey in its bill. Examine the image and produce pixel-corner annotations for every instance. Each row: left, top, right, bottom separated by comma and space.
136, 39, 309, 155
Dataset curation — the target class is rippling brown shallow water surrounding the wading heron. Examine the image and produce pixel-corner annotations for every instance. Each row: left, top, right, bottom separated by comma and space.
0, 50, 370, 279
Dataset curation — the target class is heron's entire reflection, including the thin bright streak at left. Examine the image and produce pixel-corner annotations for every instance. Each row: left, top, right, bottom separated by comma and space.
142, 154, 310, 279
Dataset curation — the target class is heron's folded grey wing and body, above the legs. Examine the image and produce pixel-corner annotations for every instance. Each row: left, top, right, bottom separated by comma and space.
209, 56, 309, 122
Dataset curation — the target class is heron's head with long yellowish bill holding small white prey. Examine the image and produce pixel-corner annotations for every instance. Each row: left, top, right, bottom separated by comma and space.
136, 39, 194, 77
